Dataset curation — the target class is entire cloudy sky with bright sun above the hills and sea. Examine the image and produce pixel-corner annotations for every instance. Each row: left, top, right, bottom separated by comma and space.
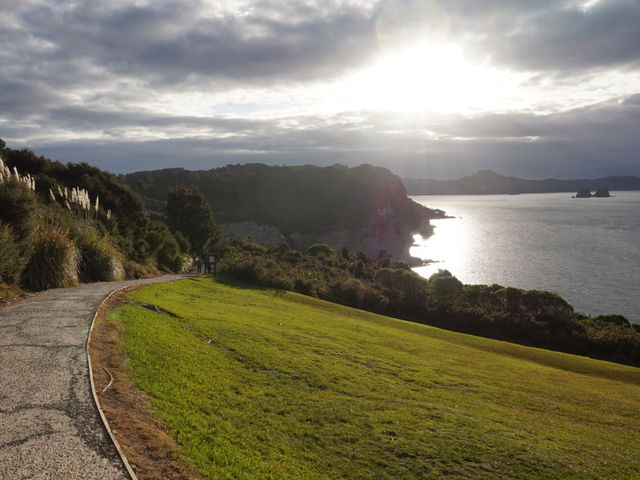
0, 0, 640, 179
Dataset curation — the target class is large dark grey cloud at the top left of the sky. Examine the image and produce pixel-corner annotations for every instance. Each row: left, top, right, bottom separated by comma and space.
14, 0, 375, 85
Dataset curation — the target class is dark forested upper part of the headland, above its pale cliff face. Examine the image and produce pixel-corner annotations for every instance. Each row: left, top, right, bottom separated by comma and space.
118, 164, 439, 235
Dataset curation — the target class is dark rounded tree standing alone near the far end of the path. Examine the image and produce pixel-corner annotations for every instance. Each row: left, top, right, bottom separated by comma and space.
167, 185, 219, 254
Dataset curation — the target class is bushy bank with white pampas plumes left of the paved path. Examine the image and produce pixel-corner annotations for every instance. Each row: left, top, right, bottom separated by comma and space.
0, 140, 218, 300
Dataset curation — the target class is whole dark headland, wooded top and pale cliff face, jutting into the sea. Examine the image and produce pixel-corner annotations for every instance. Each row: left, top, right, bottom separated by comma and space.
120, 164, 443, 258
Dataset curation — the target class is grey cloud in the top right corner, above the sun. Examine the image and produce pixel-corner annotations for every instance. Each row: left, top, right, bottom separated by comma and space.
378, 0, 640, 75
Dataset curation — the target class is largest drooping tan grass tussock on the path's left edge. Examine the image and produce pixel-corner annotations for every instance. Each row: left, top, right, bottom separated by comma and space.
22, 226, 79, 291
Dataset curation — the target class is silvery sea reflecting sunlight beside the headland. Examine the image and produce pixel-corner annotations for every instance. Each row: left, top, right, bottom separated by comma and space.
411, 192, 640, 323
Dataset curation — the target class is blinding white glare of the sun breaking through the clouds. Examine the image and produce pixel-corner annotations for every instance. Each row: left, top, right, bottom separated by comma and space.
348, 43, 515, 113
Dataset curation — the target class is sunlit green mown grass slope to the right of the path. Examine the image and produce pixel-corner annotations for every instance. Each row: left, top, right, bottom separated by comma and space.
111, 278, 640, 479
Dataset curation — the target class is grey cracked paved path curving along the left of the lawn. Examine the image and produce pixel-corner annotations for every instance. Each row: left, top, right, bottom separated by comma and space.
0, 276, 189, 480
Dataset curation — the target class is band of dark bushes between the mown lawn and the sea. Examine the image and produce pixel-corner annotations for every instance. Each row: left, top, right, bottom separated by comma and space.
222, 239, 640, 366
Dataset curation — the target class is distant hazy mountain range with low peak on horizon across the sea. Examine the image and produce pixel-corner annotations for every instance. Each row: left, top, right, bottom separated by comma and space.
403, 170, 640, 195
